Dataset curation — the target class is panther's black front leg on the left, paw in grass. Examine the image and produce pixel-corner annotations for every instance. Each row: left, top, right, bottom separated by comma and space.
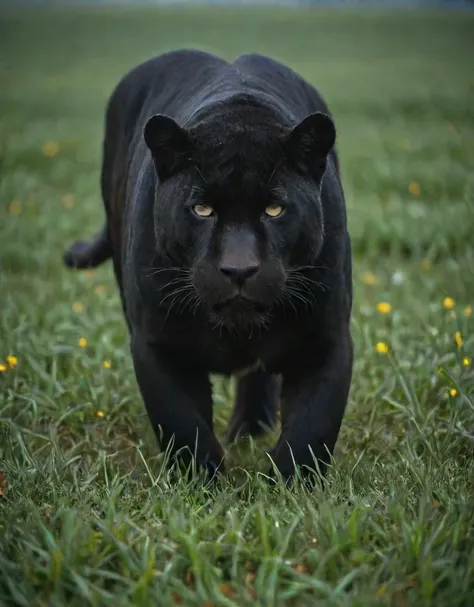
131, 333, 223, 474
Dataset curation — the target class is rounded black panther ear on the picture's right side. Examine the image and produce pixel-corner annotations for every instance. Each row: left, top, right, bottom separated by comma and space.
286, 112, 336, 172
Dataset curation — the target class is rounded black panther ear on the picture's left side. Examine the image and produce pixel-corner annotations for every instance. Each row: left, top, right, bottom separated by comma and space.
143, 114, 192, 181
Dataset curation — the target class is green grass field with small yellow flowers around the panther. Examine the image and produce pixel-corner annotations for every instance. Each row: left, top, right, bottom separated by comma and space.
0, 8, 474, 607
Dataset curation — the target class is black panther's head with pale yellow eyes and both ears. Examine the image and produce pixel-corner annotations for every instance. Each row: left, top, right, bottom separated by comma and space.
144, 96, 336, 330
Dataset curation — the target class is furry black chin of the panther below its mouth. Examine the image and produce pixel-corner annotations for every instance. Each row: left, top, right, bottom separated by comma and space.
209, 295, 270, 336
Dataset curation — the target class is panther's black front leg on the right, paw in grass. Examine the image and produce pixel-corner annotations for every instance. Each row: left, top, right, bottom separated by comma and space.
270, 329, 352, 478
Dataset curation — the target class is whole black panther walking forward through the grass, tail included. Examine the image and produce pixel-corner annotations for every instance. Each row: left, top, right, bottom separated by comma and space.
64, 50, 353, 478
